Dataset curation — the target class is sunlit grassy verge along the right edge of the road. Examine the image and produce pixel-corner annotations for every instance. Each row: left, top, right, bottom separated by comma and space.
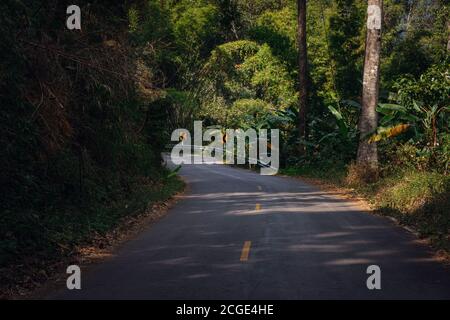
280, 166, 450, 253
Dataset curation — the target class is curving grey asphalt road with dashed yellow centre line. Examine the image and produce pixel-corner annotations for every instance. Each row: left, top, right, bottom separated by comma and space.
48, 160, 450, 299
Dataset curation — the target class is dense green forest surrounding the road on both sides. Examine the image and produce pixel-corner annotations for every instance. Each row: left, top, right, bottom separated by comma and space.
0, 0, 450, 296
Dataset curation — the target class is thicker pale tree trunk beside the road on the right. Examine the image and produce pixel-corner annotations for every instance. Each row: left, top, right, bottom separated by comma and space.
357, 0, 383, 180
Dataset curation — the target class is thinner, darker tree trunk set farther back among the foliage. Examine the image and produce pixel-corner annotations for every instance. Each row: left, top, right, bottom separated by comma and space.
297, 0, 308, 151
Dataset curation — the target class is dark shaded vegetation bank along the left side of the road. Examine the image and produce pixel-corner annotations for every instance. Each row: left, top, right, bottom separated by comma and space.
0, 1, 183, 296
